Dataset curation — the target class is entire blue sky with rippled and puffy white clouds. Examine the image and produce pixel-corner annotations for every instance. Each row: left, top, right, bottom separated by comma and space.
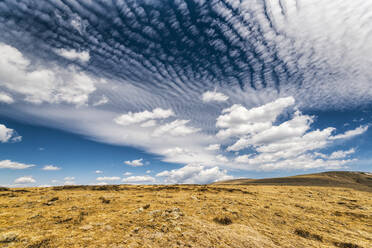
0, 0, 372, 187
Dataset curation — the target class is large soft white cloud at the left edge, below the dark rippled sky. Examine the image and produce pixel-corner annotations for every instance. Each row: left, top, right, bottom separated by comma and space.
0, 43, 96, 105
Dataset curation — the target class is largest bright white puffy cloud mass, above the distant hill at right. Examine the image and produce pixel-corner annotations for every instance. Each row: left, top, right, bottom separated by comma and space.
224, 98, 367, 170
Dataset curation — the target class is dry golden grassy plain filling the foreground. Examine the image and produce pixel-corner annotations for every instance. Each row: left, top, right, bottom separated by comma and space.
0, 182, 372, 248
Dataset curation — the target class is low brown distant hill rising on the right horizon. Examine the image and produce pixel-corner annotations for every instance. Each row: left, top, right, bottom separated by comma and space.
214, 171, 372, 191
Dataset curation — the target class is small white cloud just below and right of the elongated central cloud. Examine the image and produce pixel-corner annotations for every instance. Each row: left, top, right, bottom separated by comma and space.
152, 120, 200, 137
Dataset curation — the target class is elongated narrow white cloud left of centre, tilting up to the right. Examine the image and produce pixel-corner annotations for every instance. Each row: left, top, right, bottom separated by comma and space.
114, 108, 174, 126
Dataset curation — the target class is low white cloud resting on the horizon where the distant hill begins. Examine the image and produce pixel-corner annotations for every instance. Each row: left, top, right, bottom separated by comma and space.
156, 165, 233, 184
